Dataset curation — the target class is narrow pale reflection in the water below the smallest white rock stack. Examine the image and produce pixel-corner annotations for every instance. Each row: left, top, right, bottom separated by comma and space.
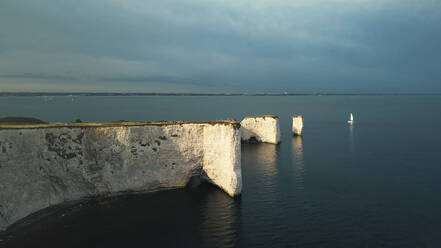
292, 136, 305, 191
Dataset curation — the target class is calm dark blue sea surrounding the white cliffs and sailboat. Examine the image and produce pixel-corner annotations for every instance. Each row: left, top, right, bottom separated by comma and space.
0, 96, 441, 247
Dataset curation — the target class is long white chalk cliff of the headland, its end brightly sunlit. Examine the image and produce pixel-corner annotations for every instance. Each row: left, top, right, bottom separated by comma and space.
0, 122, 242, 230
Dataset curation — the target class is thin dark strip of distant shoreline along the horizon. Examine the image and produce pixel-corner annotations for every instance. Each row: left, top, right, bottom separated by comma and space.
0, 92, 441, 97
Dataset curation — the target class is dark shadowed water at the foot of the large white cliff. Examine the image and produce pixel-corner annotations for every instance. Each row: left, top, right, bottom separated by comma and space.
0, 184, 240, 248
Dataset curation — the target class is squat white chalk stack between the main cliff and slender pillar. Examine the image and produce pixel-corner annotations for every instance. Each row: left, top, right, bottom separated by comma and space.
240, 115, 280, 144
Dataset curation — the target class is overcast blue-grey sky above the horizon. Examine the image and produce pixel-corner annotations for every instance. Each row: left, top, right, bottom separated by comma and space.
0, 0, 441, 93
